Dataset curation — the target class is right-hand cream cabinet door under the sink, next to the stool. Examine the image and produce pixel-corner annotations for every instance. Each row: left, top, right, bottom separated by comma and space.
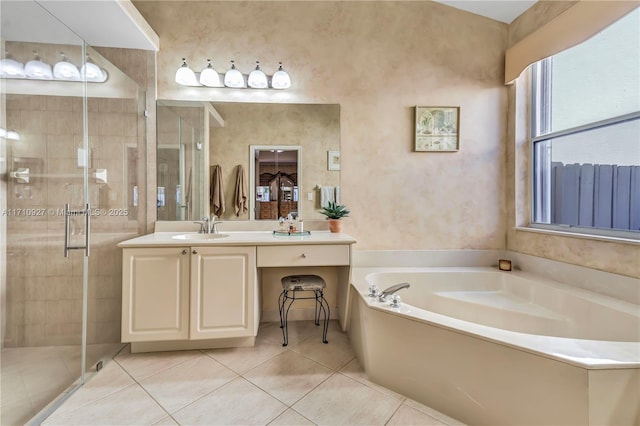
190, 247, 256, 339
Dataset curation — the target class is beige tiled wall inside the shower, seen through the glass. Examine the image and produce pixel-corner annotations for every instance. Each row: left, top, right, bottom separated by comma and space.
5, 95, 146, 347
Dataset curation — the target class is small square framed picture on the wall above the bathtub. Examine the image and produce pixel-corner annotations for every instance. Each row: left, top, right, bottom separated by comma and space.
414, 106, 460, 152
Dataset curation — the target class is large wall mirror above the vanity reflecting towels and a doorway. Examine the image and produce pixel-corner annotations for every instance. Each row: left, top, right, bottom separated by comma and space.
158, 101, 340, 221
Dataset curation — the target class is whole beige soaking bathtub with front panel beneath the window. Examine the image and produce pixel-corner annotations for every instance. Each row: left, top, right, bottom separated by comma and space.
347, 267, 640, 425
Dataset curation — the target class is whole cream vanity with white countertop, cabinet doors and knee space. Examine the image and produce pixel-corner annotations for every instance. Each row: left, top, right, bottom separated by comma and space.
118, 231, 355, 352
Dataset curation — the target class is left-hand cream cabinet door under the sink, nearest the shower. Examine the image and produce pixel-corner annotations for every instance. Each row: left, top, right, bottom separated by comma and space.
122, 247, 190, 342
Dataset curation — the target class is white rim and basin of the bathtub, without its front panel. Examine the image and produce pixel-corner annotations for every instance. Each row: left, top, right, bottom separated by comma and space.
352, 267, 640, 369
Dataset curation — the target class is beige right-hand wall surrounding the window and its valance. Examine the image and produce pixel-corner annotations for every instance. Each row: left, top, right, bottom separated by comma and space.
507, 2, 640, 277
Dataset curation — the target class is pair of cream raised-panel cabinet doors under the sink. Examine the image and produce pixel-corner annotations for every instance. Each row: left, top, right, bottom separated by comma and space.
122, 246, 256, 342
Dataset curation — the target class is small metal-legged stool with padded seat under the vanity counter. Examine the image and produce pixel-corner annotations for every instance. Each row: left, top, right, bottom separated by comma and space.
278, 275, 329, 346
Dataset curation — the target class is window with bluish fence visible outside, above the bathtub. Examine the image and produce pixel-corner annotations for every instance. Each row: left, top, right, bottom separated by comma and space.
531, 9, 640, 239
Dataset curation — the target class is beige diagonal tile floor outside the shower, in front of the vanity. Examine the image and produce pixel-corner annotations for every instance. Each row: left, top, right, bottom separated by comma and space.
38, 321, 461, 425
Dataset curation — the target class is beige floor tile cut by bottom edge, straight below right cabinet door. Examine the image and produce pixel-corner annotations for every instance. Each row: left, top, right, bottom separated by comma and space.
173, 378, 287, 425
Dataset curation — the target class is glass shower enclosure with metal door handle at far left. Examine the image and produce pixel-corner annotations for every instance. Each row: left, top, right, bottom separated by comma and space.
0, 0, 146, 425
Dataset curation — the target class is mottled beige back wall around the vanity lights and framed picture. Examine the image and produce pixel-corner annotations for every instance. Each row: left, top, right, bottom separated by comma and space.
134, 1, 508, 250
